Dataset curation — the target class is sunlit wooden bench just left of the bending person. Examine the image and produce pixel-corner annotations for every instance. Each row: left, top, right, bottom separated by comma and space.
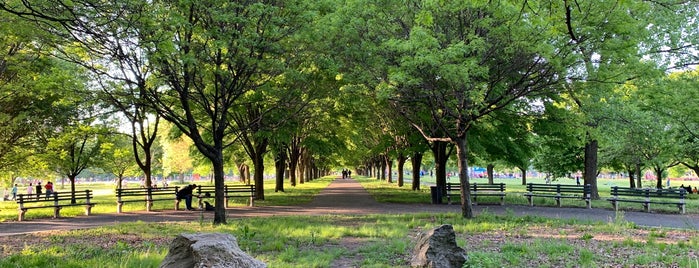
116, 186, 180, 213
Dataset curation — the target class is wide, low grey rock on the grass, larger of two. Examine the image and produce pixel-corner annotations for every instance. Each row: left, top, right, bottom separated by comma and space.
160, 233, 267, 268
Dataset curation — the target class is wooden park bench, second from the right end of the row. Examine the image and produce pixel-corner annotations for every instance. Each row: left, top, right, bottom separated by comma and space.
524, 183, 592, 208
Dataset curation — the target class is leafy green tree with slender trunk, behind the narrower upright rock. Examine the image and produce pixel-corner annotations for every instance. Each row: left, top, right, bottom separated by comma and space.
378, 3, 565, 218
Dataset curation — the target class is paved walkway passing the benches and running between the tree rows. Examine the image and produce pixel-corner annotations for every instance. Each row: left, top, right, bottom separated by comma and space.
0, 179, 699, 236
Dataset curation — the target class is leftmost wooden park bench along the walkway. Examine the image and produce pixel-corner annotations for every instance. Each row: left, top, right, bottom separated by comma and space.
17, 190, 95, 221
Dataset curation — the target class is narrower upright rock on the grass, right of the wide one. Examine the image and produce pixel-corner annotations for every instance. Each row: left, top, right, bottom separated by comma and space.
410, 224, 467, 268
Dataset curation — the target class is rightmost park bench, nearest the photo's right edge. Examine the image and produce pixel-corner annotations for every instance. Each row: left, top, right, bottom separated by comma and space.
607, 186, 687, 214
